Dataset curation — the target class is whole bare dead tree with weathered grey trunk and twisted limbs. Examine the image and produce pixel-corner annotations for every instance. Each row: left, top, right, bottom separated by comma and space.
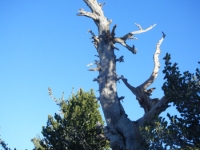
77, 0, 168, 150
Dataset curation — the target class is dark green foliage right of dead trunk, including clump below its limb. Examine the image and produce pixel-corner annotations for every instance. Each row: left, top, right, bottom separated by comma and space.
141, 54, 200, 150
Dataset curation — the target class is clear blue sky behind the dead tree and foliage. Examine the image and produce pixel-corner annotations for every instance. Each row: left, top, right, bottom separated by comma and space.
0, 0, 200, 150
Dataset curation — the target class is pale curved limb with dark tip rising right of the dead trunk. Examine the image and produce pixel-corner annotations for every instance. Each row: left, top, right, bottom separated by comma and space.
139, 32, 166, 90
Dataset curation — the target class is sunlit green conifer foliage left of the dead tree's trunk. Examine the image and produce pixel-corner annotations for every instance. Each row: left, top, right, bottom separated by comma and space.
34, 89, 108, 150
